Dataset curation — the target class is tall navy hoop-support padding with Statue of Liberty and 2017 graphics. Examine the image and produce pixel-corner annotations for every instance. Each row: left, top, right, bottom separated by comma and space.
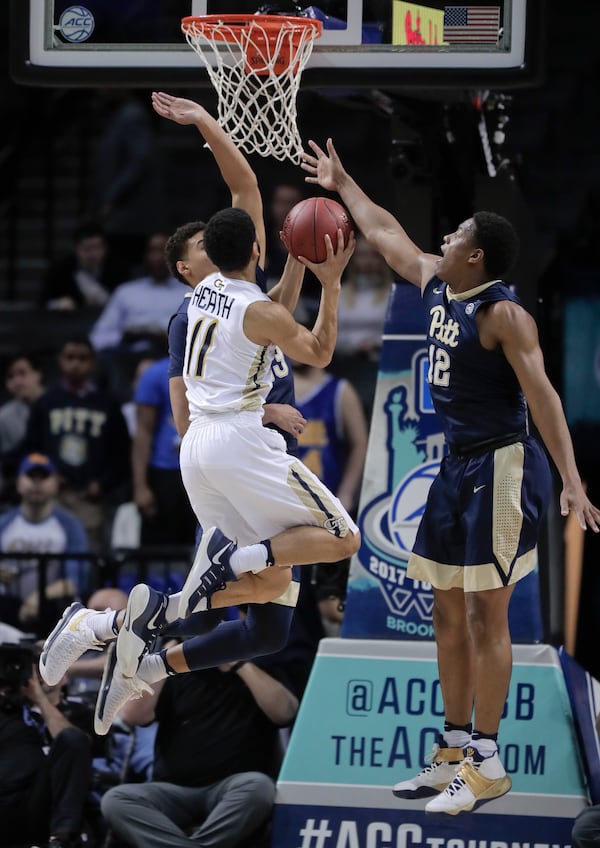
341, 283, 543, 643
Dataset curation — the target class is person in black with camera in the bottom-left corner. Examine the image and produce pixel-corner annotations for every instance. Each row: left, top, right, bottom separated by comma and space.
0, 641, 92, 848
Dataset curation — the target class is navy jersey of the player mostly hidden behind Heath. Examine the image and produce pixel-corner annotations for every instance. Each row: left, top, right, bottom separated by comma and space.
168, 268, 298, 453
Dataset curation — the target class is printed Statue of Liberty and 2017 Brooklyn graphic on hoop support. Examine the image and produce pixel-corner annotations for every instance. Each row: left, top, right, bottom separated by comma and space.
342, 362, 444, 639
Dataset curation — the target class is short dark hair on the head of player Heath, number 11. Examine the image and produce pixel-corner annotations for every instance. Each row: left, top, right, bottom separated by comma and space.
204, 209, 256, 274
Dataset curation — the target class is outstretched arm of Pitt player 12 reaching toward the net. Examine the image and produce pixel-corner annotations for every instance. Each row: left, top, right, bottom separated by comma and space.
301, 138, 439, 288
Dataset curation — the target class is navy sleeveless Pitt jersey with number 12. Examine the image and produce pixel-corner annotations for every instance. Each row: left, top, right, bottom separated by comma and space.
423, 277, 527, 447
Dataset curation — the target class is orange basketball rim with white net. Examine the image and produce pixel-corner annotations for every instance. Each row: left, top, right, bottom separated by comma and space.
181, 15, 323, 163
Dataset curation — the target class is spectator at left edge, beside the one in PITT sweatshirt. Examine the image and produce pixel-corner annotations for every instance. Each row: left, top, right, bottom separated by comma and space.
0, 354, 44, 501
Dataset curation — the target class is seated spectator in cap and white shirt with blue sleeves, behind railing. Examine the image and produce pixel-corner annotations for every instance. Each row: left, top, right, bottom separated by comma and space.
0, 453, 89, 633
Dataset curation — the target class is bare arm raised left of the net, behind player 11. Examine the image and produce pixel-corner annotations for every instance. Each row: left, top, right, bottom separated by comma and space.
152, 91, 266, 256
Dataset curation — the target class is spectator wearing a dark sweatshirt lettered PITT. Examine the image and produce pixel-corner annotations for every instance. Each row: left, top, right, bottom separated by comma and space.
25, 337, 131, 552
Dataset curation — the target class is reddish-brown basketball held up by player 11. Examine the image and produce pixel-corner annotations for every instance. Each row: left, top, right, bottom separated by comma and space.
282, 197, 352, 262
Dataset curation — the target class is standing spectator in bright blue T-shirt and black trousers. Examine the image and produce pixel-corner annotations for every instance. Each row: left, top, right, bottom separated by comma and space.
131, 357, 197, 546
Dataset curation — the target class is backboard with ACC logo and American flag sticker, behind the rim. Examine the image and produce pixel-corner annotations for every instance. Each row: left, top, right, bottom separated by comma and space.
10, 0, 544, 90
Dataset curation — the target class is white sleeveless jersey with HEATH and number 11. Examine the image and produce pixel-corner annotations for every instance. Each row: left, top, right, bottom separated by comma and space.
183, 272, 275, 420
